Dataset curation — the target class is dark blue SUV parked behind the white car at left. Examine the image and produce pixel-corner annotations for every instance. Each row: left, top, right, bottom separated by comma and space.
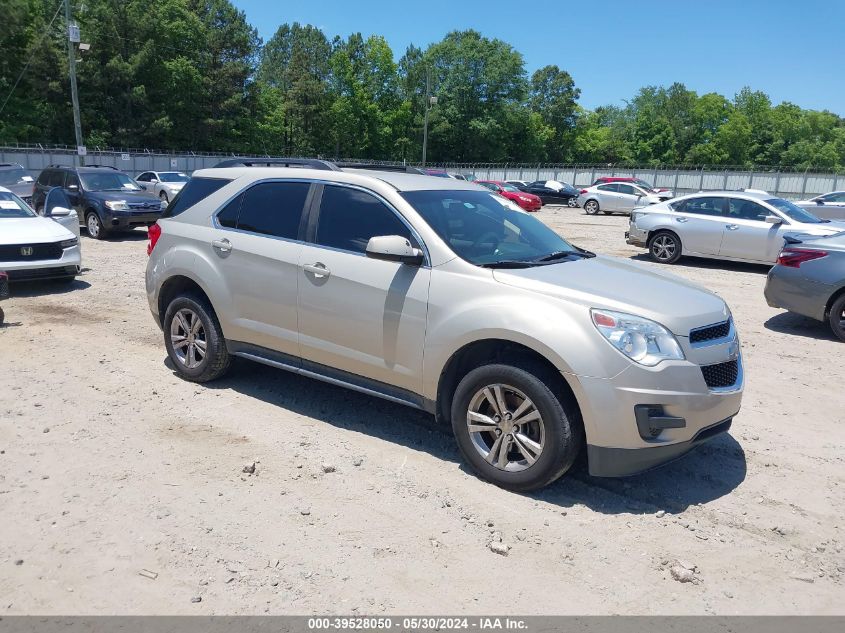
32, 165, 162, 240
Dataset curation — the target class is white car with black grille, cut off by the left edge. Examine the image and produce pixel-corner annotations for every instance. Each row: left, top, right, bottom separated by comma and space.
0, 187, 82, 281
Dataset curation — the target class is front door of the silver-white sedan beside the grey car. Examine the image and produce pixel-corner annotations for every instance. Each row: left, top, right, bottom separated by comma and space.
719, 198, 794, 264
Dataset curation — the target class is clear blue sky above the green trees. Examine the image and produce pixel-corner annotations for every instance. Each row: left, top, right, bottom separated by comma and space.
233, 0, 845, 115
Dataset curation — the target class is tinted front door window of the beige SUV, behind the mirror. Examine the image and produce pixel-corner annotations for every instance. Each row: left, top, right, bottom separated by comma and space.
315, 185, 414, 253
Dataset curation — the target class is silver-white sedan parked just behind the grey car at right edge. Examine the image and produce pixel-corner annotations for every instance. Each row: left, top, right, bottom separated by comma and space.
625, 191, 845, 264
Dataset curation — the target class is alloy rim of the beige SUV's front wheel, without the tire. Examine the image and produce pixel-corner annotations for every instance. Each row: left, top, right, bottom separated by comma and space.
467, 384, 546, 472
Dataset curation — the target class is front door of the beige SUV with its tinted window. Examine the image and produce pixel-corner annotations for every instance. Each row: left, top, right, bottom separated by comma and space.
299, 185, 431, 393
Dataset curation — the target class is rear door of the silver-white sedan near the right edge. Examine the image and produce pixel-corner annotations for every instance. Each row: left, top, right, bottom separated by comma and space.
670, 196, 726, 256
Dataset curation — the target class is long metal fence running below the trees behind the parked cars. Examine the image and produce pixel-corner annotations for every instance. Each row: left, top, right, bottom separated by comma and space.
0, 145, 845, 198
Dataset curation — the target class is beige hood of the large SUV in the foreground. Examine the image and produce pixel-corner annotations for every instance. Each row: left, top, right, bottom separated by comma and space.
493, 256, 729, 336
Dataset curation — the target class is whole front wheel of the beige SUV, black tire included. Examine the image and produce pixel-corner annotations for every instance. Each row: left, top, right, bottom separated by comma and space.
451, 364, 583, 492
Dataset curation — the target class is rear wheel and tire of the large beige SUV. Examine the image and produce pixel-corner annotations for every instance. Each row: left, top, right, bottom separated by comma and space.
162, 295, 232, 382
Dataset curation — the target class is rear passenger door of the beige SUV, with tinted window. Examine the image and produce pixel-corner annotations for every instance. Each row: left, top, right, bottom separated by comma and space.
208, 180, 311, 357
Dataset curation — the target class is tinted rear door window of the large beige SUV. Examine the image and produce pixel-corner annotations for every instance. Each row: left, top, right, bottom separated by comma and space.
234, 182, 311, 240
